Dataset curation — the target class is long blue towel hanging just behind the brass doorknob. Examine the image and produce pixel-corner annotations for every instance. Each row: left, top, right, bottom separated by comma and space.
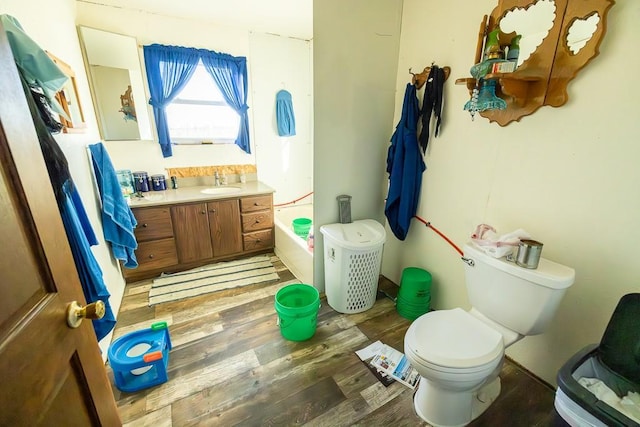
60, 181, 116, 341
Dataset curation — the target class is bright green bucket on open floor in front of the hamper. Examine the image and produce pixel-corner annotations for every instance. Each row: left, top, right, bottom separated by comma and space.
275, 283, 320, 341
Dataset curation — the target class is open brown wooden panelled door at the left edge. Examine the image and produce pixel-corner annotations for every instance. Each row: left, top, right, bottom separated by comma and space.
0, 25, 121, 426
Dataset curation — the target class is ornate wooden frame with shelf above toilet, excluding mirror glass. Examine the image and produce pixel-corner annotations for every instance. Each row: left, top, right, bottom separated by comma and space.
456, 0, 615, 126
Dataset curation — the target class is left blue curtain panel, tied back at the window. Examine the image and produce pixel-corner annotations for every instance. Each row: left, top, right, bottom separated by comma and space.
143, 44, 200, 157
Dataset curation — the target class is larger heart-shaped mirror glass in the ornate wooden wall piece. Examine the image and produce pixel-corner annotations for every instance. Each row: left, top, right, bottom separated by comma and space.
500, 0, 556, 67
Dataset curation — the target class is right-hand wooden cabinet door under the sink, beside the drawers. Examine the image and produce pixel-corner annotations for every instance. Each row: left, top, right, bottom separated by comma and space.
207, 199, 242, 257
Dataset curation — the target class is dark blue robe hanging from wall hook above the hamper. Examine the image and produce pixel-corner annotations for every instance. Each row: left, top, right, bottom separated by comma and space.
384, 83, 427, 240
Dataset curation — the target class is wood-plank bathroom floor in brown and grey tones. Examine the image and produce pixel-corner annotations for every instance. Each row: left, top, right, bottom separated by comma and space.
107, 257, 564, 427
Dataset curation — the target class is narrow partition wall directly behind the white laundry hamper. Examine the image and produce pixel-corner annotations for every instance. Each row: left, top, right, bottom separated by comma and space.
313, 0, 402, 290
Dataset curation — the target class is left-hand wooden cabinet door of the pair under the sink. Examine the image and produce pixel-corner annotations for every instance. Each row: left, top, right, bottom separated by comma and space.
171, 203, 213, 263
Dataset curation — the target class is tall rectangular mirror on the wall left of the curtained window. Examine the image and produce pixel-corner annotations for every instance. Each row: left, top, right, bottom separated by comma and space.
79, 27, 152, 141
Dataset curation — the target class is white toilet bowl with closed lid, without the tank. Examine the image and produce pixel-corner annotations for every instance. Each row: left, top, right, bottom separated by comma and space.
404, 308, 504, 426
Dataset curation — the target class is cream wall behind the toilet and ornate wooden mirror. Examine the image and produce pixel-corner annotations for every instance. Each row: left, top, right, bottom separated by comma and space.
383, 0, 640, 383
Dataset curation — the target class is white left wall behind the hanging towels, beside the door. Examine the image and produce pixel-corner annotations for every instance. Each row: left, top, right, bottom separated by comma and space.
0, 0, 124, 358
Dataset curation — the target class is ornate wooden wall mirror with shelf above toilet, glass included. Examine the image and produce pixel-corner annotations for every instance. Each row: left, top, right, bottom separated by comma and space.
456, 0, 615, 126
